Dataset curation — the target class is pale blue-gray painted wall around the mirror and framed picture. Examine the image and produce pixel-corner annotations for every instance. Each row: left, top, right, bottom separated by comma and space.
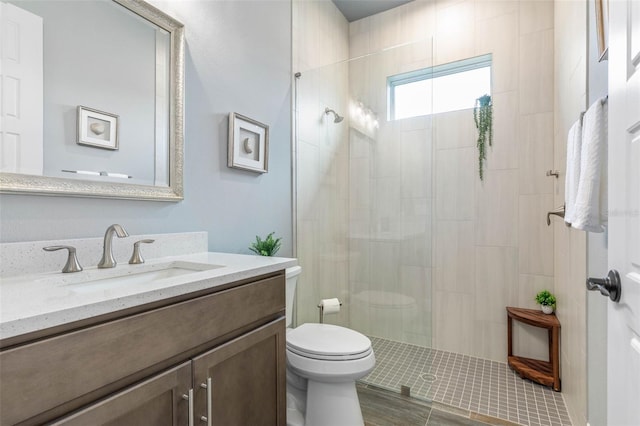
0, 0, 292, 256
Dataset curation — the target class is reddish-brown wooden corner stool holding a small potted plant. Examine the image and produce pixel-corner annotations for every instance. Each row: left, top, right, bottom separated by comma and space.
507, 306, 560, 392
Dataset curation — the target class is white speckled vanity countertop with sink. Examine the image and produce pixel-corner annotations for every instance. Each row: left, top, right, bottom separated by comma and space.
0, 252, 298, 339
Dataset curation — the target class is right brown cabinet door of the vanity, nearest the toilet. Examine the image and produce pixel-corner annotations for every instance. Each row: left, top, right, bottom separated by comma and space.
193, 318, 286, 426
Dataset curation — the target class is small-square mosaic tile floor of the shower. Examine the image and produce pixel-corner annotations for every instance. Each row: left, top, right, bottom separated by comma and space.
361, 337, 571, 426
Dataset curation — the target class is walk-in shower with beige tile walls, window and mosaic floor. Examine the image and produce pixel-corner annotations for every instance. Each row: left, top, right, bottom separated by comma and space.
293, 1, 565, 424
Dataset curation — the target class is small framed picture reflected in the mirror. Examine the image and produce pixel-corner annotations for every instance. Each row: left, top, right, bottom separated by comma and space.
77, 105, 118, 150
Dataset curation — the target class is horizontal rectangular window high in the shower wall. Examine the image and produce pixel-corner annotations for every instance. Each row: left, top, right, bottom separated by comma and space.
387, 54, 491, 120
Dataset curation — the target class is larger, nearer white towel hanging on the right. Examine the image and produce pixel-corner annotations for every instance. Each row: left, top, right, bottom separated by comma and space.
571, 99, 608, 232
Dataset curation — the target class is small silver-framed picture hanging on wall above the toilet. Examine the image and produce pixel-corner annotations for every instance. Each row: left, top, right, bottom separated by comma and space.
227, 112, 269, 173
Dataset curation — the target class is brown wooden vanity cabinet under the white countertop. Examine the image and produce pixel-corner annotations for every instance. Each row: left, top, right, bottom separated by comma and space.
0, 271, 286, 426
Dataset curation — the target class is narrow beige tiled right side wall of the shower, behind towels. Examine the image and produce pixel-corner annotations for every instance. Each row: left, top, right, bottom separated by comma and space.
553, 1, 588, 425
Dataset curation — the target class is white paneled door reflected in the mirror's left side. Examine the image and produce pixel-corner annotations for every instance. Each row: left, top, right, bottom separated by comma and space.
0, 2, 43, 175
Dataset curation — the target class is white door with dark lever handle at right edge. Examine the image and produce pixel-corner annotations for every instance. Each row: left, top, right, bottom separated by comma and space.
607, 0, 640, 426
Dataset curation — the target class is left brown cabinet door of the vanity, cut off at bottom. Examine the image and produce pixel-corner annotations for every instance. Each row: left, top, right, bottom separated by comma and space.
53, 362, 191, 426
